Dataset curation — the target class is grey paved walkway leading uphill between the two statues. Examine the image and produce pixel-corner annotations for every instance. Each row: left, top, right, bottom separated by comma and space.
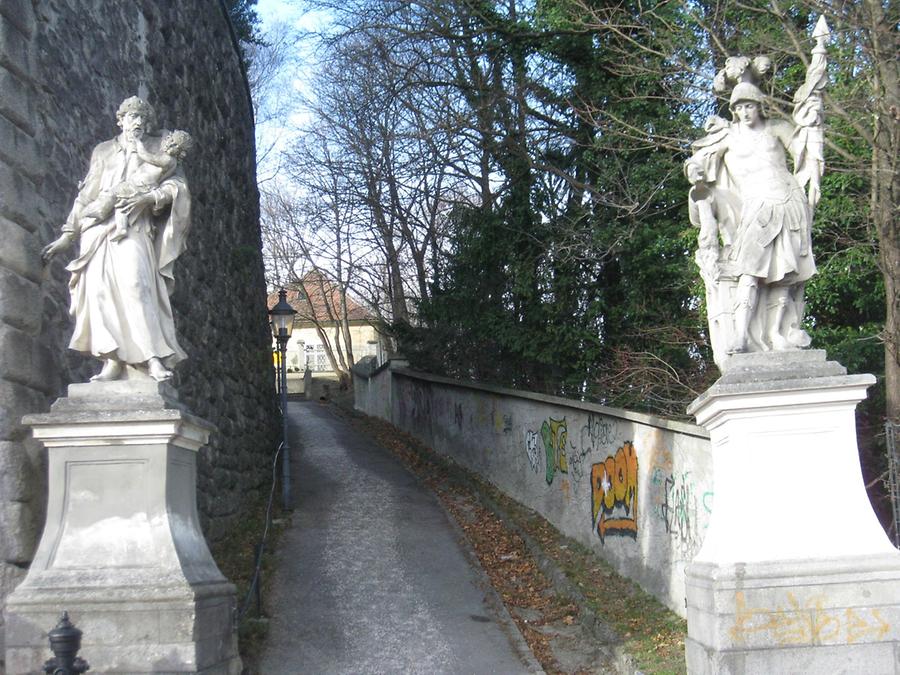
260, 402, 539, 675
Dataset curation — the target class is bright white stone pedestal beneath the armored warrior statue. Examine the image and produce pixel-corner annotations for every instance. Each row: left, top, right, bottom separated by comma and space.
686, 350, 900, 674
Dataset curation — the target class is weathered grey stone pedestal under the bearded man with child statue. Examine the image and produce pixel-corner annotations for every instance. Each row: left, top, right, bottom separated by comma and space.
6, 372, 241, 674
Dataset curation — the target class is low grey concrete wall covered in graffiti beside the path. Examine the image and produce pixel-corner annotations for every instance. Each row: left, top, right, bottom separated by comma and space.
354, 365, 713, 616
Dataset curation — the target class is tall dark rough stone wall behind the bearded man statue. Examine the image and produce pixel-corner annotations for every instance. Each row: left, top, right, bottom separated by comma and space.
0, 0, 278, 654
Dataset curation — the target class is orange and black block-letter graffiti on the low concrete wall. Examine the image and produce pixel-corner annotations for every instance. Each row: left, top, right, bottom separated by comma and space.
591, 441, 638, 542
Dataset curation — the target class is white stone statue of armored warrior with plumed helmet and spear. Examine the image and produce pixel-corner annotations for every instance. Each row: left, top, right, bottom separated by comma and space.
685, 20, 828, 368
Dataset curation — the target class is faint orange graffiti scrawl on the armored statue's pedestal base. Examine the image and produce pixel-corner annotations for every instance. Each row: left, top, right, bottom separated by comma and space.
729, 591, 891, 645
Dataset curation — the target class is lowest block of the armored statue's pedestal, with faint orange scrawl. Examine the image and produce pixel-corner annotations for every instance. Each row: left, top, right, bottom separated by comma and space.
686, 553, 900, 675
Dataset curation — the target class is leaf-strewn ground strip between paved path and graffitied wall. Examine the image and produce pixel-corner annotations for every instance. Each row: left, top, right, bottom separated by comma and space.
339, 402, 687, 675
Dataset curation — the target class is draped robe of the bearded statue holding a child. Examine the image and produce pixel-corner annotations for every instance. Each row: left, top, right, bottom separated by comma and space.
63, 136, 190, 368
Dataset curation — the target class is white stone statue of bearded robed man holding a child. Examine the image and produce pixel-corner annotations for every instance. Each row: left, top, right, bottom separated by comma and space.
42, 96, 192, 381
